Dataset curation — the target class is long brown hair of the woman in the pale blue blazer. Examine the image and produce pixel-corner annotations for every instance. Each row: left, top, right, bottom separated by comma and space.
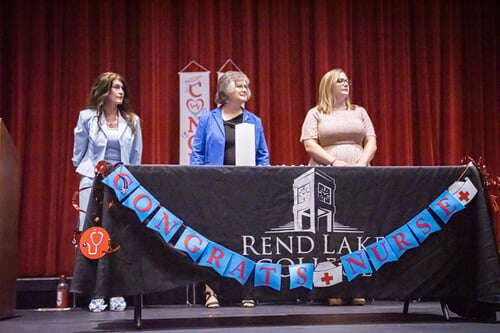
88, 72, 136, 133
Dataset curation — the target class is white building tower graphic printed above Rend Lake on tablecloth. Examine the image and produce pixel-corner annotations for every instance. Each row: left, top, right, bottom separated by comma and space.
266, 168, 363, 233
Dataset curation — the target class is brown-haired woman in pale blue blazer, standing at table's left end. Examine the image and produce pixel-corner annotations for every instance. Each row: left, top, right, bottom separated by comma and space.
72, 72, 142, 312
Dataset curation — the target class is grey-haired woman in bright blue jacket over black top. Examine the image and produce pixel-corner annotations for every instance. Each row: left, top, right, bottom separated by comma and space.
191, 71, 269, 308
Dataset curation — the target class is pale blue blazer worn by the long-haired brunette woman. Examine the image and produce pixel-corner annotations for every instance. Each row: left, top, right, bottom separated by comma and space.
72, 109, 142, 178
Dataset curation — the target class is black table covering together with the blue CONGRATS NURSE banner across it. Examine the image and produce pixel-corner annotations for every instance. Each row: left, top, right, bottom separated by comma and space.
74, 166, 500, 299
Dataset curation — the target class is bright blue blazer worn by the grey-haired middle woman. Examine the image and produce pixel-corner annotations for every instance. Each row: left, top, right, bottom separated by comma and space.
191, 108, 269, 165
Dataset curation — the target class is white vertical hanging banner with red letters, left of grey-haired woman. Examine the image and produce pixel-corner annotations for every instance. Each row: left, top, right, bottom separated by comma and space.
179, 71, 210, 165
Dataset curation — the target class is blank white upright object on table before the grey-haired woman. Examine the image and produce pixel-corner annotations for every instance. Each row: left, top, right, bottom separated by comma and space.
234, 123, 255, 166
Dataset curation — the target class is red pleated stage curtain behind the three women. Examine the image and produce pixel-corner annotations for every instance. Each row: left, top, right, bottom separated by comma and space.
0, 0, 500, 276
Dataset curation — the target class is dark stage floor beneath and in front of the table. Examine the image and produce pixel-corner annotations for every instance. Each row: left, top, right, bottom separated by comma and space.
0, 301, 500, 333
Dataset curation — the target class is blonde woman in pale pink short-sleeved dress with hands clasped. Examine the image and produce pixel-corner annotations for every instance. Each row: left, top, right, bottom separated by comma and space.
300, 69, 377, 305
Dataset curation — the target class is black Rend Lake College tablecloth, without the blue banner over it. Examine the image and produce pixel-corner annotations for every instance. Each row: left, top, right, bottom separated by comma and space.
72, 165, 500, 312
